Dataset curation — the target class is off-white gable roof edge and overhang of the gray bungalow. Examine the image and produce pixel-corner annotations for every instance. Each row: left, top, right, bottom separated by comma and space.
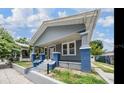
29, 9, 100, 45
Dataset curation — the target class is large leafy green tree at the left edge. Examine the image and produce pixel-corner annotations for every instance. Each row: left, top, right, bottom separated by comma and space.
0, 27, 19, 58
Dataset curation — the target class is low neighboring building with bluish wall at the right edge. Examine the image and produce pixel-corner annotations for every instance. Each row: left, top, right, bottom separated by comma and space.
95, 51, 114, 64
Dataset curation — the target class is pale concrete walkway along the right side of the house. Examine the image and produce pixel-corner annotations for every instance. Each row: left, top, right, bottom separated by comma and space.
91, 63, 114, 84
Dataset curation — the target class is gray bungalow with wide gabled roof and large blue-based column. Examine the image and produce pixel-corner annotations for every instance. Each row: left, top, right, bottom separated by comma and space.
30, 10, 100, 71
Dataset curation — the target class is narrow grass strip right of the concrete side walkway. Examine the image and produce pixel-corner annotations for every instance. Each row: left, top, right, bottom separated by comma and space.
93, 62, 114, 73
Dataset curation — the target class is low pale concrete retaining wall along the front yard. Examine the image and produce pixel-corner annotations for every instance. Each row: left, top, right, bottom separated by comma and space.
12, 63, 64, 84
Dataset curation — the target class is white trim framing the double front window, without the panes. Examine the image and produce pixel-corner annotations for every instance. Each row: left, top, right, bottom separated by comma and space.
61, 40, 76, 56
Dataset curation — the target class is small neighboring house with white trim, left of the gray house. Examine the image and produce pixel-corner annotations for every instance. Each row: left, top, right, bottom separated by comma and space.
15, 42, 31, 61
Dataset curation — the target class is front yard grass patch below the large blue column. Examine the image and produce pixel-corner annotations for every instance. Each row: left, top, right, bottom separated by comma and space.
52, 69, 106, 84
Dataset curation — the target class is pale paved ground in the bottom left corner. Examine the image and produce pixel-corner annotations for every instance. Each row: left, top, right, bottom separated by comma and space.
0, 68, 32, 84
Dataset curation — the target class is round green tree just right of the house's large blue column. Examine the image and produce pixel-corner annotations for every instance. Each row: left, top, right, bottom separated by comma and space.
90, 40, 104, 55
